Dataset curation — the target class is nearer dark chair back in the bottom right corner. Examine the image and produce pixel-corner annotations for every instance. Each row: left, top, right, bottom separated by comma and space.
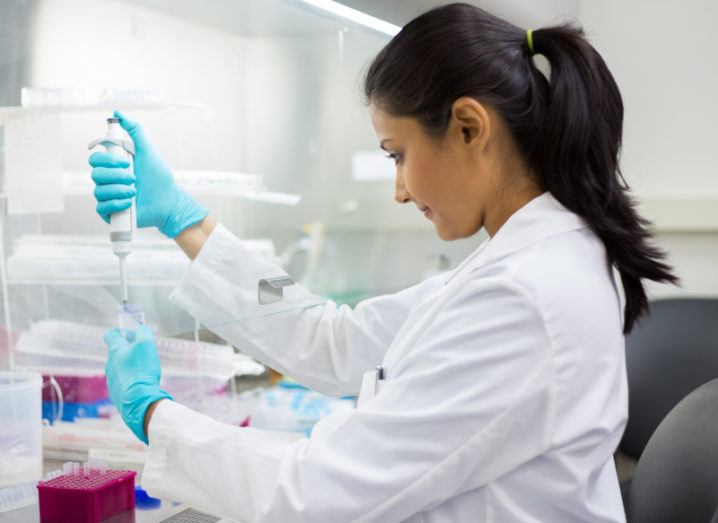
628, 379, 718, 523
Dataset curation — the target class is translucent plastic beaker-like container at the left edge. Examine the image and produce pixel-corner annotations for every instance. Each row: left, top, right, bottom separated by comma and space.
0, 371, 42, 488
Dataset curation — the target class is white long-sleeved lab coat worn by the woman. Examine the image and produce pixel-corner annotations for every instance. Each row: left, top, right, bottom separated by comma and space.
143, 193, 627, 523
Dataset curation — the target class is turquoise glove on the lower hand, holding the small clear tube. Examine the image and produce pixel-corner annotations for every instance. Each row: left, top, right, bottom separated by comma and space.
104, 325, 172, 443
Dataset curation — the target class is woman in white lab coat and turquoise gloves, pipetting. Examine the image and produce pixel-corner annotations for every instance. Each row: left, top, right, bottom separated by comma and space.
90, 4, 676, 523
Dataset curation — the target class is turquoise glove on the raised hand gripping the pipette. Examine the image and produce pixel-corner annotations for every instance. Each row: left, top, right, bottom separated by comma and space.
90, 111, 207, 238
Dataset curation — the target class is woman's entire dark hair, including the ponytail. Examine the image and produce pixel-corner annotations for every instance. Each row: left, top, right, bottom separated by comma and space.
364, 3, 678, 333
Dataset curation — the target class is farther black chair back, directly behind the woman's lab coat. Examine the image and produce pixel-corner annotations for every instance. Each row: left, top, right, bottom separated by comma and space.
619, 298, 718, 459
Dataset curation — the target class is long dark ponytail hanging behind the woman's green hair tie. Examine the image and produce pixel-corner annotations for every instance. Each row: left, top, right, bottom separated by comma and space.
531, 24, 678, 333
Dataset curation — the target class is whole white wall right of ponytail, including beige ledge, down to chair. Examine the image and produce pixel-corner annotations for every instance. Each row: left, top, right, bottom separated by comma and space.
580, 0, 718, 297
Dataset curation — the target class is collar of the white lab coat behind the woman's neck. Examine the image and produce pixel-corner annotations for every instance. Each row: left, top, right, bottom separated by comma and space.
471, 192, 588, 269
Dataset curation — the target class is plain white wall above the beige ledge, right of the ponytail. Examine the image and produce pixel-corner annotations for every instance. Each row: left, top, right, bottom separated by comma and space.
581, 0, 718, 198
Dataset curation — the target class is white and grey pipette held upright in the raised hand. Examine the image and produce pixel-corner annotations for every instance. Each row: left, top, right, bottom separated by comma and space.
88, 117, 137, 304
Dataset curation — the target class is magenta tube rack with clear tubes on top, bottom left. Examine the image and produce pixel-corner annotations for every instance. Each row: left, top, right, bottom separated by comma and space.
37, 461, 137, 523
